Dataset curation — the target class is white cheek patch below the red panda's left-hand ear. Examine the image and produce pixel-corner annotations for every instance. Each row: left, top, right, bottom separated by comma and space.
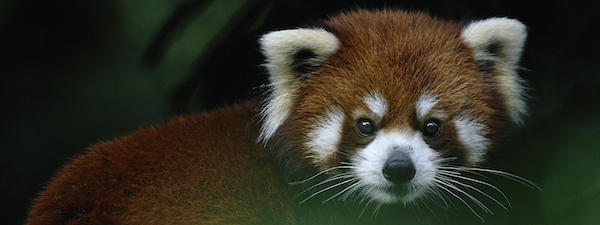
306, 108, 344, 163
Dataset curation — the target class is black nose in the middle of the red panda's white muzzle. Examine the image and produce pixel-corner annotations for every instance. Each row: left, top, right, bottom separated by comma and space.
383, 151, 415, 184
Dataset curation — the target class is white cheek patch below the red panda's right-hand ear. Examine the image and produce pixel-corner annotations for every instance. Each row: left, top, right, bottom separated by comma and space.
454, 116, 489, 164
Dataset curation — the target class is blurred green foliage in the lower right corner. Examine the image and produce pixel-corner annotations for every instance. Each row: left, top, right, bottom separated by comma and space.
541, 114, 600, 225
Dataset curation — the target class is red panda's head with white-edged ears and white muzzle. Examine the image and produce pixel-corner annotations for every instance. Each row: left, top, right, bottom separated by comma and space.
259, 10, 526, 203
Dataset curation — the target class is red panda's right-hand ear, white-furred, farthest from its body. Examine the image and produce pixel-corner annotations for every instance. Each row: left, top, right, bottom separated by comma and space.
461, 18, 527, 125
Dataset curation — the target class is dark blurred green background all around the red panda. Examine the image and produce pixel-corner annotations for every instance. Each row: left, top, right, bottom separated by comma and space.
0, 0, 600, 225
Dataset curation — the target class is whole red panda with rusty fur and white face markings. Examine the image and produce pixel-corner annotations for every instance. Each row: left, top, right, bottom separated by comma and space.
26, 10, 526, 225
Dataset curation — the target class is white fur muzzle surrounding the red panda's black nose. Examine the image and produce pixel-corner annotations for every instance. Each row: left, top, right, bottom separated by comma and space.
351, 131, 439, 203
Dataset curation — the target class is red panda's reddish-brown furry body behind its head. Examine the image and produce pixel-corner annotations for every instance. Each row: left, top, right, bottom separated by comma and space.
27, 102, 291, 225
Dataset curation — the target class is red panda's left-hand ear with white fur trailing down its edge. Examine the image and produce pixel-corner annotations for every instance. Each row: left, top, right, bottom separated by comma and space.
259, 29, 340, 141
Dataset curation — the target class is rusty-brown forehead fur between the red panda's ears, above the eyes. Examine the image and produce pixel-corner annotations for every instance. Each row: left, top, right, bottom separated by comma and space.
298, 10, 502, 125
